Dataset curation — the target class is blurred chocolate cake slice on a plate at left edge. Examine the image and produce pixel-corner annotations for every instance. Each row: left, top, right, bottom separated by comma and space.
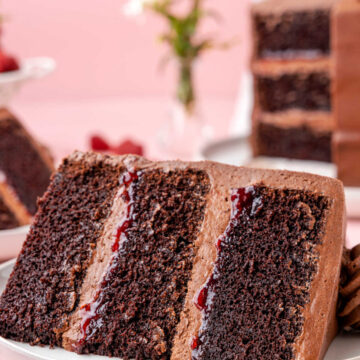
0, 109, 53, 229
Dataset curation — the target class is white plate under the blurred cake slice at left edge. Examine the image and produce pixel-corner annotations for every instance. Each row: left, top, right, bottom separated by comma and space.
0, 225, 30, 262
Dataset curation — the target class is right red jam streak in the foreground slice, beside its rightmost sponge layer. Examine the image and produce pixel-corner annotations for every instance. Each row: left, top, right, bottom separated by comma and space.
191, 186, 262, 359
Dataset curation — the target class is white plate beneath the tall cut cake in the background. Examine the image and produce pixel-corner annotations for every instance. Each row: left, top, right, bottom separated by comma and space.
201, 136, 360, 218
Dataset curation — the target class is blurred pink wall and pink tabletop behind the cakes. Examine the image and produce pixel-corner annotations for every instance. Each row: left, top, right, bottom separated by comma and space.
1, 0, 253, 160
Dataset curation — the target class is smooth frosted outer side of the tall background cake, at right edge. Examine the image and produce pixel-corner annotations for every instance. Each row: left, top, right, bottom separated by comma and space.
332, 0, 360, 186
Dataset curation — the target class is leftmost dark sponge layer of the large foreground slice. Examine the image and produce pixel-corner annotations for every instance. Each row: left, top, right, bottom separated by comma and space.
0, 154, 122, 346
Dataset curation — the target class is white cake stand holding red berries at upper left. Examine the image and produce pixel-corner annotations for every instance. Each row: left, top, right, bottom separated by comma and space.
0, 57, 56, 107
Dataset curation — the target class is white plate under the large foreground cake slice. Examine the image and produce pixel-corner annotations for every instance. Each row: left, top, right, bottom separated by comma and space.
0, 260, 360, 360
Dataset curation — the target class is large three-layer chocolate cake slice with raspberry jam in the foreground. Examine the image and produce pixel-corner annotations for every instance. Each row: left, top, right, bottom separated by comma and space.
0, 153, 345, 360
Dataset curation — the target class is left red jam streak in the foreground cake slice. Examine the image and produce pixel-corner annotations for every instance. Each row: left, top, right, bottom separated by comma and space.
79, 171, 139, 345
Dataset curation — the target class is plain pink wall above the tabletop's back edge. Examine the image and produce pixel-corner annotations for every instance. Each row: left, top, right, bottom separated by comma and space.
1, 0, 248, 101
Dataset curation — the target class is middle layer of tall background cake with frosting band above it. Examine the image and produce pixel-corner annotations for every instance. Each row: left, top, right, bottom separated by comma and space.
252, 59, 331, 112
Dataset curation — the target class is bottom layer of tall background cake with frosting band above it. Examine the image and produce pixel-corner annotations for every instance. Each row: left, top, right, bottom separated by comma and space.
253, 112, 333, 162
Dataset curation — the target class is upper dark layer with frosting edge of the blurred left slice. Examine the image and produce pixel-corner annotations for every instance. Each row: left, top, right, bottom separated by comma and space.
0, 109, 52, 215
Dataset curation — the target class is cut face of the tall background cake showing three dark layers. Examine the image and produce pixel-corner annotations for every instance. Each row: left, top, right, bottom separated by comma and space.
252, 0, 336, 162
